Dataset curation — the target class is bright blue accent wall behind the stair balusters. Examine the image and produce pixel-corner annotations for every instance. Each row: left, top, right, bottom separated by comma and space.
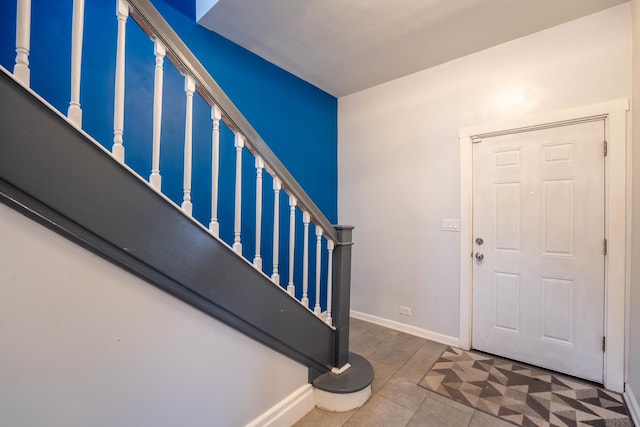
0, 0, 337, 308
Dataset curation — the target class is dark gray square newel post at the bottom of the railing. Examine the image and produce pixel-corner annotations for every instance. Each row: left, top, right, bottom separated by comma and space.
331, 225, 354, 369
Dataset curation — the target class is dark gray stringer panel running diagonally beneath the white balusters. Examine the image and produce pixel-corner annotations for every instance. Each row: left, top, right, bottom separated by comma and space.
0, 67, 335, 371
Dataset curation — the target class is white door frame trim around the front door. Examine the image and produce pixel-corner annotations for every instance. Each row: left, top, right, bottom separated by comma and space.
458, 98, 631, 392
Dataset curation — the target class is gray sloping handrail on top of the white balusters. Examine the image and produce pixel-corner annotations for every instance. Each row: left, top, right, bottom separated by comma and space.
127, 0, 340, 244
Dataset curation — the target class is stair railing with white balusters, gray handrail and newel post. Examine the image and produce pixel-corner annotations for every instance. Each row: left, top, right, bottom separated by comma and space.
7, 0, 352, 368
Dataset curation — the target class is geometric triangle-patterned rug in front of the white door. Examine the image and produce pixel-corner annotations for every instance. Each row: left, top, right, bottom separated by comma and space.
420, 347, 633, 427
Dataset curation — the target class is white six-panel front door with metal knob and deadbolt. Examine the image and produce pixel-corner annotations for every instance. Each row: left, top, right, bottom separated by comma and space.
472, 120, 605, 382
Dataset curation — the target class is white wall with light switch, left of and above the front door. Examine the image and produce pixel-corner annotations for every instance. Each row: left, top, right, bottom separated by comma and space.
338, 3, 631, 337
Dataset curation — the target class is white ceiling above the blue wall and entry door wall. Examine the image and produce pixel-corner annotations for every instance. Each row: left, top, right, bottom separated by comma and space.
197, 0, 627, 97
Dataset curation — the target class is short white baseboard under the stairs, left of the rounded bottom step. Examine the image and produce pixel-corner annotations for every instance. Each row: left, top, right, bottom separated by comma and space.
246, 384, 316, 427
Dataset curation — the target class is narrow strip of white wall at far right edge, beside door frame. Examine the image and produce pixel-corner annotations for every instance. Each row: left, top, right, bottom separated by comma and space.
627, 0, 640, 423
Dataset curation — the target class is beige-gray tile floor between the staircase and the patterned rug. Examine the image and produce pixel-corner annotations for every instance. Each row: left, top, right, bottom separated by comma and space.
295, 319, 632, 427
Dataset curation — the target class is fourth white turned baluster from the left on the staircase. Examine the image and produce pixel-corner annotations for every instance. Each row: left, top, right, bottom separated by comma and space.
149, 37, 167, 191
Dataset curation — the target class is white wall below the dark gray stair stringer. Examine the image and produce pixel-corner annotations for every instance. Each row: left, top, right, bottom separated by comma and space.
0, 204, 307, 427
